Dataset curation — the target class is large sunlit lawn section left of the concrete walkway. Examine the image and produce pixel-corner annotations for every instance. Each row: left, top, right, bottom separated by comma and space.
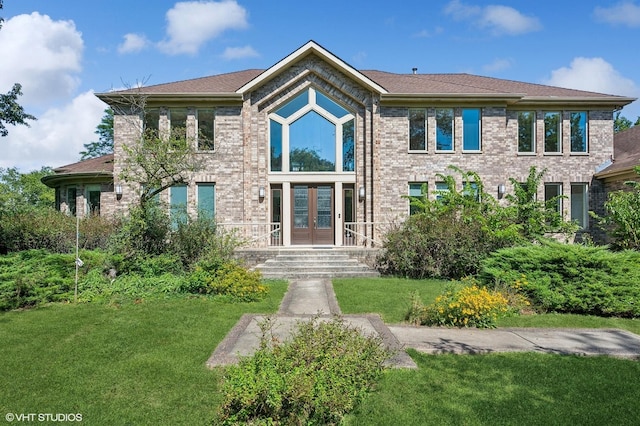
0, 282, 286, 425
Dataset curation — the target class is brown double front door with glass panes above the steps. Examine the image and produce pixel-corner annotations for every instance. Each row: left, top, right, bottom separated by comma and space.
291, 184, 334, 245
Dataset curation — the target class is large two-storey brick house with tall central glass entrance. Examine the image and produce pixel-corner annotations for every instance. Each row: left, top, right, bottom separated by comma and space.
45, 41, 634, 246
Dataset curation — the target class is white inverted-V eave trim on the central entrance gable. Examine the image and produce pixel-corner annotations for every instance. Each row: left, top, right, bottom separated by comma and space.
236, 41, 388, 95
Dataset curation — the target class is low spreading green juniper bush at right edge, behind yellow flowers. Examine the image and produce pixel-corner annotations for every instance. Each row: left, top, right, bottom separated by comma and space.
480, 242, 640, 317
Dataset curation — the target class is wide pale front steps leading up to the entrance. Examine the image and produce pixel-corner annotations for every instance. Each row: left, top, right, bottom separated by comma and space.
250, 248, 380, 279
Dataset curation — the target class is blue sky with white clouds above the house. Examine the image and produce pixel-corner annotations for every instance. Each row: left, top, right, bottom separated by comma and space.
0, 0, 640, 172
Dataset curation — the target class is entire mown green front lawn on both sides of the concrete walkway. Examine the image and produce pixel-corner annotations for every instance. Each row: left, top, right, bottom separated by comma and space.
0, 279, 640, 425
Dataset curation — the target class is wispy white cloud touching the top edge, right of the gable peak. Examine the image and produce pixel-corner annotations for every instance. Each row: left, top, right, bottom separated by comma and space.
444, 0, 542, 35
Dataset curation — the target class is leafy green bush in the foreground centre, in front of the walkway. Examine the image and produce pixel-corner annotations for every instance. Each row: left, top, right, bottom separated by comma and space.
216, 318, 390, 425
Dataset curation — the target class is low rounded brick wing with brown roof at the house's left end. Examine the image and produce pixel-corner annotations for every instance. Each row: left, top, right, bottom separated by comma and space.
42, 154, 116, 216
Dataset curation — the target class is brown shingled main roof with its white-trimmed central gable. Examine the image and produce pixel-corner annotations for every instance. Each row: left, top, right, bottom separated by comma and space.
97, 41, 635, 109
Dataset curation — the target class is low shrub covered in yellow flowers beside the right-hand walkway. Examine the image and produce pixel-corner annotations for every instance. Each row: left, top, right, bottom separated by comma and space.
407, 280, 508, 328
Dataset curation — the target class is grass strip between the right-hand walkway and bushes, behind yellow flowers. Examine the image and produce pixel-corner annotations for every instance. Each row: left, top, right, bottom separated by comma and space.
333, 278, 640, 334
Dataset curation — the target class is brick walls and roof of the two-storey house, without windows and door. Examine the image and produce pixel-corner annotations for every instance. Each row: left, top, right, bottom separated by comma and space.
45, 42, 631, 245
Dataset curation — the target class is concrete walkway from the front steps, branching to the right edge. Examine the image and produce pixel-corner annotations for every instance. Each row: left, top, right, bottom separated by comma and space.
207, 279, 640, 368
